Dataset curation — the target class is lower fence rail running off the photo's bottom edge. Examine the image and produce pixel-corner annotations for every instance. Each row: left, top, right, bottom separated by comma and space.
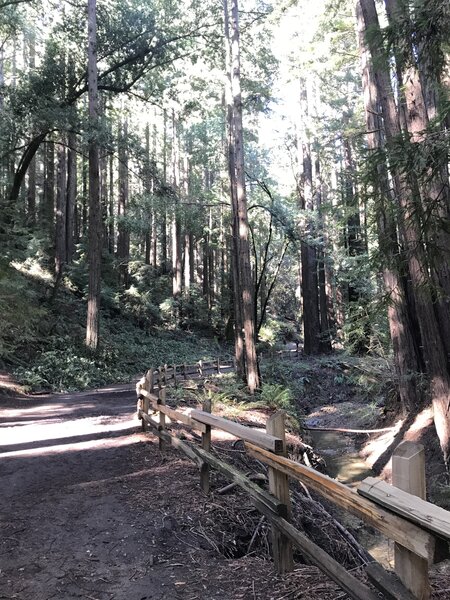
251, 504, 379, 600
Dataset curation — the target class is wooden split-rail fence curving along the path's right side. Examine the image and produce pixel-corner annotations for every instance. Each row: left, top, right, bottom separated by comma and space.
136, 360, 450, 600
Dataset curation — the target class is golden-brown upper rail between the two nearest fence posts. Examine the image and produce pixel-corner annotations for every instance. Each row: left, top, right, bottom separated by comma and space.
245, 443, 434, 564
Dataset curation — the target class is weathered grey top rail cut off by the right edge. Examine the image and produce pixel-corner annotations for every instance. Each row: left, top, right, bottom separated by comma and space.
358, 477, 450, 540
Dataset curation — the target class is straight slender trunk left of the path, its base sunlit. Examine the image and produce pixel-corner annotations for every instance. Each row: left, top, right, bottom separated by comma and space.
86, 0, 102, 351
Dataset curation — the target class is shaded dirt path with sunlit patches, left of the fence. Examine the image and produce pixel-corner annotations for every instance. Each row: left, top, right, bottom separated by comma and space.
0, 386, 290, 600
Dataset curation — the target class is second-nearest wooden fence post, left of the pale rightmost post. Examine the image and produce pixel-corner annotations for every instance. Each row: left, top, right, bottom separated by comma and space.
266, 411, 294, 574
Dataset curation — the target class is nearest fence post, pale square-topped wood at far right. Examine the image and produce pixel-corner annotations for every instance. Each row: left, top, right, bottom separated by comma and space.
392, 442, 431, 600
